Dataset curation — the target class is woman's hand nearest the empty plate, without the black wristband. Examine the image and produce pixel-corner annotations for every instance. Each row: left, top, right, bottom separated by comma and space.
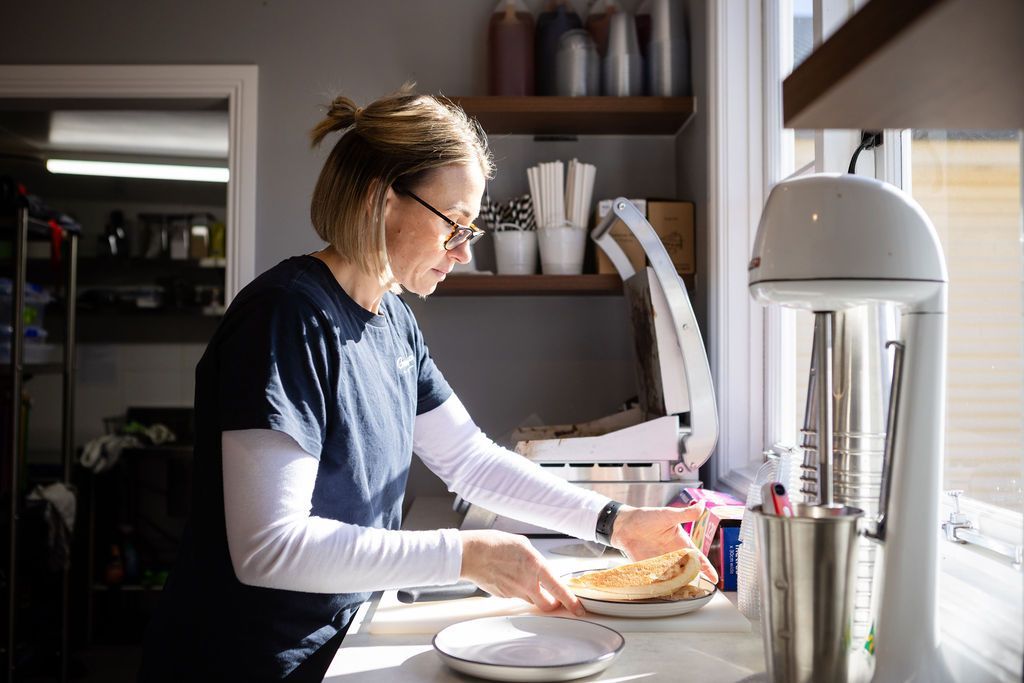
460, 529, 585, 616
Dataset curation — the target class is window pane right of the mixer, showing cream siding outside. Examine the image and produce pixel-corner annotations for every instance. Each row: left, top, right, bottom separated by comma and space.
905, 130, 1024, 512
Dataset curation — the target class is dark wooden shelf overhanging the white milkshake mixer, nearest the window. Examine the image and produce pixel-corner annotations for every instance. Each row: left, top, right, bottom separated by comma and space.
782, 0, 1024, 130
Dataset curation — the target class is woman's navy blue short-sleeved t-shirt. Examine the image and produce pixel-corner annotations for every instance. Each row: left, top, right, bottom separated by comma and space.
141, 256, 452, 681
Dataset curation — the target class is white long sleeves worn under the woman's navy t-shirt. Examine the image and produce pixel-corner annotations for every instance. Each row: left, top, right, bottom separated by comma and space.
221, 394, 608, 593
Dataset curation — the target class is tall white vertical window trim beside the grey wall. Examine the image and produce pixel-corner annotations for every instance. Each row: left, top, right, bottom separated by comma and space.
707, 2, 765, 496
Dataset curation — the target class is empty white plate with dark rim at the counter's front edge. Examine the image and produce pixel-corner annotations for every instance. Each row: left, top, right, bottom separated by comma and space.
434, 616, 626, 681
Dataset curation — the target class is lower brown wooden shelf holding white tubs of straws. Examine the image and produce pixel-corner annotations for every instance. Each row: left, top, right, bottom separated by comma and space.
434, 274, 623, 296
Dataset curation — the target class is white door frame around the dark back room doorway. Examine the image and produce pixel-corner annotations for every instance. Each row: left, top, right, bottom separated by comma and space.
0, 65, 258, 303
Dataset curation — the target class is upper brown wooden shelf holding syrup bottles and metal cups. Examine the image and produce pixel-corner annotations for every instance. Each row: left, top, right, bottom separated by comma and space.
452, 97, 696, 135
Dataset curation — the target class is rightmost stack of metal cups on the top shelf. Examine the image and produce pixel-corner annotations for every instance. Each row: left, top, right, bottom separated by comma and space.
646, 0, 690, 97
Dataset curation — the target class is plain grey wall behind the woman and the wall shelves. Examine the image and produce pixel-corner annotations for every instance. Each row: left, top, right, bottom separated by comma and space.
0, 0, 707, 501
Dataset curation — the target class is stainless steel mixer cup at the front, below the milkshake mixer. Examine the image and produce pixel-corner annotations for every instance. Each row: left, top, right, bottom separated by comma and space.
752, 504, 863, 683
